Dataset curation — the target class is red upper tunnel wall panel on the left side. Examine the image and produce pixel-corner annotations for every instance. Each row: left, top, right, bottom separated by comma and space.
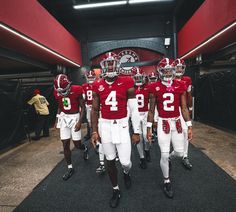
0, 0, 82, 64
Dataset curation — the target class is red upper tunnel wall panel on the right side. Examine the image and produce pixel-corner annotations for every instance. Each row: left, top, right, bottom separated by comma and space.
178, 0, 236, 57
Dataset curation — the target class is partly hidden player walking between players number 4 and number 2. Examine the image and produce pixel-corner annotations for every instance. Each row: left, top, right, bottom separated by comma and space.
133, 68, 150, 169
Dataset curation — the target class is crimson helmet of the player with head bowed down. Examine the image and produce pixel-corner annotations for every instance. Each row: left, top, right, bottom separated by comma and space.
54, 74, 71, 96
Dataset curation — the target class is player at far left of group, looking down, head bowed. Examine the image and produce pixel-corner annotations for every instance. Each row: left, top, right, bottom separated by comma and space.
54, 74, 88, 180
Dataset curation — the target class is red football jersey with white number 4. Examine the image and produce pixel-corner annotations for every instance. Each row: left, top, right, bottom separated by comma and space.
93, 77, 134, 119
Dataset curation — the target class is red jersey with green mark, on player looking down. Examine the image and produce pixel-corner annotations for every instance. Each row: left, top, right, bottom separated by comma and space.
53, 85, 83, 113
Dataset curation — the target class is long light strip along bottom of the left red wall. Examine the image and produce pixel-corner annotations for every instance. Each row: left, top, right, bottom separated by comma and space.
0, 23, 80, 67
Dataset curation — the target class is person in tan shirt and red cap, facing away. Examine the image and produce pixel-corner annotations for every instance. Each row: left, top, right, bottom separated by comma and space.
27, 89, 49, 140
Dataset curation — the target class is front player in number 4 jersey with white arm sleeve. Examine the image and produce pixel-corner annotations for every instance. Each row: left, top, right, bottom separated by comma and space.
91, 52, 140, 208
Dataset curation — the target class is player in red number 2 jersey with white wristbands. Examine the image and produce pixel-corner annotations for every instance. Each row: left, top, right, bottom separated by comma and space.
147, 58, 192, 198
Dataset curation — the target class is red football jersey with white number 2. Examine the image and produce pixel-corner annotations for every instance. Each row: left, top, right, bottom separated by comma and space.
150, 80, 186, 118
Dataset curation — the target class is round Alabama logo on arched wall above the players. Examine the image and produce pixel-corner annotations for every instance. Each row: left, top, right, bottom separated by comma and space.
118, 49, 139, 75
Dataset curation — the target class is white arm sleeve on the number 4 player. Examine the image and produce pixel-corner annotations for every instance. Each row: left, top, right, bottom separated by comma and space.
128, 98, 140, 134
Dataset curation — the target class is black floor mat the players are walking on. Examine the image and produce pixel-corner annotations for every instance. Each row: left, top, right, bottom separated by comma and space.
15, 143, 236, 212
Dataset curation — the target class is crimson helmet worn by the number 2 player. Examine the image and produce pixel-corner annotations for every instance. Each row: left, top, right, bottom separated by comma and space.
158, 58, 175, 82
